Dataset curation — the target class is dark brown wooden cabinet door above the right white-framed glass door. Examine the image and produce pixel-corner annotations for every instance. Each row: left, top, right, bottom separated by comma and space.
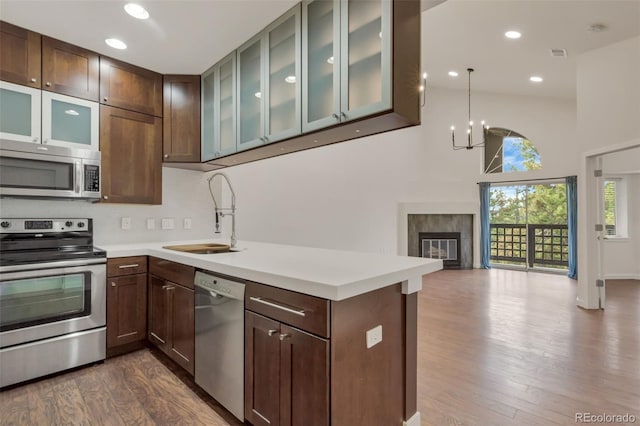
42, 36, 100, 102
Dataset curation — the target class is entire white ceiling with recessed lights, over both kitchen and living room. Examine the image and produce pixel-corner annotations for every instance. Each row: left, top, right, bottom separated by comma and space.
0, 0, 640, 99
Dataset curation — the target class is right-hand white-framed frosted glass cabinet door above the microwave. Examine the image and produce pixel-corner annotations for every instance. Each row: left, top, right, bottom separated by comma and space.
42, 91, 100, 151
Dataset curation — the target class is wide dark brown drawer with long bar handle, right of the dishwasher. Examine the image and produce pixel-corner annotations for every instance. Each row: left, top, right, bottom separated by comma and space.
245, 281, 330, 337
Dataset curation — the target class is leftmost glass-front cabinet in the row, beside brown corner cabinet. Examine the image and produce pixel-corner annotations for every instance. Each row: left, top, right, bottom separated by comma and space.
202, 51, 236, 161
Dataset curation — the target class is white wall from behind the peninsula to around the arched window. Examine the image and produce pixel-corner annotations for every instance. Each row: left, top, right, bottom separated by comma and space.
225, 88, 578, 253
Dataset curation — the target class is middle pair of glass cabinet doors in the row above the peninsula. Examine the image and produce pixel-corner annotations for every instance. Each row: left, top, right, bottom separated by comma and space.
237, 5, 302, 151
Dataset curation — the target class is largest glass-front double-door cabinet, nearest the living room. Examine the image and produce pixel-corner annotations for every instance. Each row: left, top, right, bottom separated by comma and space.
302, 0, 392, 132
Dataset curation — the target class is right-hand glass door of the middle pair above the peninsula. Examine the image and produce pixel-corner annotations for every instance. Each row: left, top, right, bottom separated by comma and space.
264, 5, 302, 143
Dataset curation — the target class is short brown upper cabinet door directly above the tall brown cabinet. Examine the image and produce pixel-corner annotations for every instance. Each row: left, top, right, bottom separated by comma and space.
100, 56, 162, 117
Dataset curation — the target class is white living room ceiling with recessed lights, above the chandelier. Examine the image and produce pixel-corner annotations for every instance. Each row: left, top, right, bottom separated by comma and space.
422, 0, 640, 99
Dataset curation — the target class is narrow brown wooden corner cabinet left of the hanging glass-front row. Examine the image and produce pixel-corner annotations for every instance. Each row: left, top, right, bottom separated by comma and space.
162, 75, 200, 163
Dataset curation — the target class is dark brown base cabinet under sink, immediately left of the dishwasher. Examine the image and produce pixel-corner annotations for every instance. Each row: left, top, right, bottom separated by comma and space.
148, 257, 195, 375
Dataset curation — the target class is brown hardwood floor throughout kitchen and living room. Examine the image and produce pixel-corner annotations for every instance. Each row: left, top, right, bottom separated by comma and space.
0, 269, 640, 426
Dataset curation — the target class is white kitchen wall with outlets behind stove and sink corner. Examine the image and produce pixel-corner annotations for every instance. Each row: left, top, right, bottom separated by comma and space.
0, 167, 213, 246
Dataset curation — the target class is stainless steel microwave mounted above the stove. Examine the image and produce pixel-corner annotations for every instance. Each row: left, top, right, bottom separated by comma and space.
0, 140, 100, 201
